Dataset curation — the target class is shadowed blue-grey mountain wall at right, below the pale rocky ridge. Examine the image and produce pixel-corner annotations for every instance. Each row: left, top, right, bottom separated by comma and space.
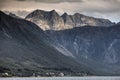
46, 24, 120, 75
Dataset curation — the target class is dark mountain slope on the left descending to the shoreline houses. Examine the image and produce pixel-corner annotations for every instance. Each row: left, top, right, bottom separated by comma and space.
0, 11, 89, 76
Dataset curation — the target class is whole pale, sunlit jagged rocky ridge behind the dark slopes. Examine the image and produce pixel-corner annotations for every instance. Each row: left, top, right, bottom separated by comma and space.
25, 9, 114, 30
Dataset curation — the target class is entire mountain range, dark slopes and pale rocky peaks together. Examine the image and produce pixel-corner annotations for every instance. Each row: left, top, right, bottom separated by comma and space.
0, 10, 120, 76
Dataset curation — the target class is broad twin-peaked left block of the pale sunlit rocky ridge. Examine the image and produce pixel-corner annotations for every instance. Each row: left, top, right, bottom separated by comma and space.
26, 10, 64, 30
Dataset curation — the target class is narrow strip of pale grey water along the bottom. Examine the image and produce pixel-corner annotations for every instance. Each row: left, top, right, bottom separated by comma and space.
0, 77, 120, 80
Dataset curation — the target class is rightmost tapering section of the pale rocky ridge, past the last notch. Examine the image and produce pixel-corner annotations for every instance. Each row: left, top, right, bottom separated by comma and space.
72, 13, 112, 27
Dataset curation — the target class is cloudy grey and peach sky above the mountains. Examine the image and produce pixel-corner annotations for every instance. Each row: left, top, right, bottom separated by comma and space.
0, 0, 120, 22
